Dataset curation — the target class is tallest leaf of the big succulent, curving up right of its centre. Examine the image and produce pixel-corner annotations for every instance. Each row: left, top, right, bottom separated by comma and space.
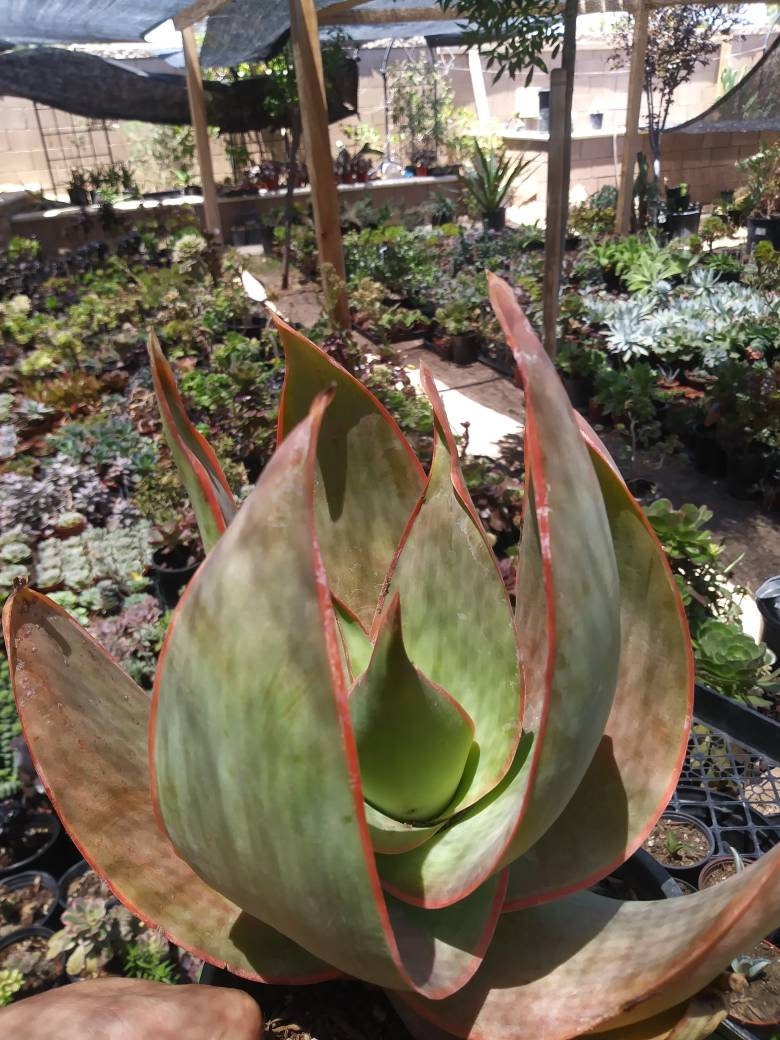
380, 289, 620, 907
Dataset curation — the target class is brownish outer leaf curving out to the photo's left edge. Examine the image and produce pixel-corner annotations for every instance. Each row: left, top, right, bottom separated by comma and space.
3, 589, 338, 983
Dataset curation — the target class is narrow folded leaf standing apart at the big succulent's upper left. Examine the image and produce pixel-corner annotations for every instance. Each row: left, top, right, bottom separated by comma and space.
148, 332, 236, 552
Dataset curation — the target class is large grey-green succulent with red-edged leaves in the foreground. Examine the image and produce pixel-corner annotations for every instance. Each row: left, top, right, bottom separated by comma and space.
5, 279, 780, 1040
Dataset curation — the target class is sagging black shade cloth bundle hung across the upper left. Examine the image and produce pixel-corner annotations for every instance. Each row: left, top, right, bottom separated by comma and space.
0, 47, 358, 132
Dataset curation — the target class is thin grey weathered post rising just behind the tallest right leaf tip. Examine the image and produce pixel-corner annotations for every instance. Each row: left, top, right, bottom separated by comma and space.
543, 0, 577, 358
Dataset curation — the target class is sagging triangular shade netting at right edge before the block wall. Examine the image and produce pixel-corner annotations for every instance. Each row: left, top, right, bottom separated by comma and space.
670, 36, 780, 133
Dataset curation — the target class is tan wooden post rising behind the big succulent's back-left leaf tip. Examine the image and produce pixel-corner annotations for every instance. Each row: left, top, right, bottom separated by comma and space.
289, 0, 349, 329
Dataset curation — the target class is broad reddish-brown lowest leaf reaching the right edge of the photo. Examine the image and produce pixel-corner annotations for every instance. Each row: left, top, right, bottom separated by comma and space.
402, 847, 780, 1040
